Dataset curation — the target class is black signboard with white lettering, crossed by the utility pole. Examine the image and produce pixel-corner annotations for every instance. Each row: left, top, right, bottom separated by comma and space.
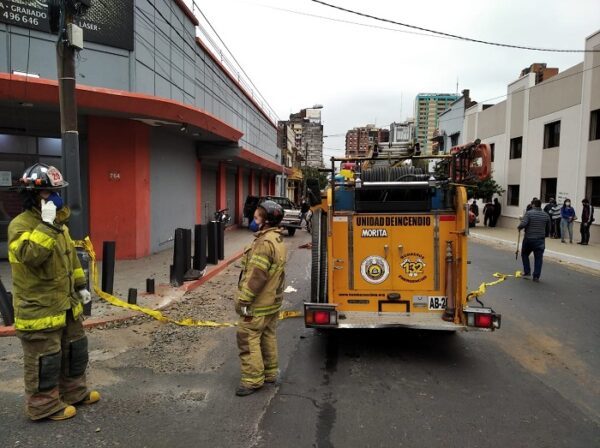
0, 0, 134, 51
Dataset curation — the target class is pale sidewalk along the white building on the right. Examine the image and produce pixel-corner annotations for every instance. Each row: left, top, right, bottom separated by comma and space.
469, 226, 600, 273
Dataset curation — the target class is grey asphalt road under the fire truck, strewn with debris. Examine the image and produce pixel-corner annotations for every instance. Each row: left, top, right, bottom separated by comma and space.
0, 232, 600, 448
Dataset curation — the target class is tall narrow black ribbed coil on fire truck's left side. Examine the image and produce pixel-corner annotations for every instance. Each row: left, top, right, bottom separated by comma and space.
310, 209, 327, 303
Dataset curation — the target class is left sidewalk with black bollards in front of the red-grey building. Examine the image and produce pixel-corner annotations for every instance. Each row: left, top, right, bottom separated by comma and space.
0, 228, 253, 336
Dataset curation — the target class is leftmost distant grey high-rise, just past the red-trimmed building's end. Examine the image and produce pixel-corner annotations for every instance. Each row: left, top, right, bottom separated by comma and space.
289, 105, 323, 168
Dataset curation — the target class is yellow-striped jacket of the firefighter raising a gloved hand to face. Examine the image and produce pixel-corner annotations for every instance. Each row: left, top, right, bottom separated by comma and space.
8, 207, 86, 331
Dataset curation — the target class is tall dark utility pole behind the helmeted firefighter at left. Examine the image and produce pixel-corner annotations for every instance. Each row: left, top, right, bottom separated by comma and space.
51, 0, 91, 239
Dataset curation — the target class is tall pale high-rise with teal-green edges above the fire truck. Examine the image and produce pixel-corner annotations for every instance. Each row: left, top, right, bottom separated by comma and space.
415, 93, 459, 155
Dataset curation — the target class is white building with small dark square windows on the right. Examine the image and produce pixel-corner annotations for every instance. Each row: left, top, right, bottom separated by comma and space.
463, 31, 600, 243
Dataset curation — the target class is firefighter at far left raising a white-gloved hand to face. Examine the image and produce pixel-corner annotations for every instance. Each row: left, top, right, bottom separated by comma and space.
8, 163, 100, 420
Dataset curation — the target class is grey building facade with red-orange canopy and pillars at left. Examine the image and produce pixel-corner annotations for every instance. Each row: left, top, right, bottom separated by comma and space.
0, 0, 283, 259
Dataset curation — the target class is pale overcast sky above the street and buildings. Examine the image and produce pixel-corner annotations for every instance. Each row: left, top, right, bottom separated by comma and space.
189, 0, 600, 157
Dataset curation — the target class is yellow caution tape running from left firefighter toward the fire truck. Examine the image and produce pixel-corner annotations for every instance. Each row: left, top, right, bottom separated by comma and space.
74, 237, 302, 327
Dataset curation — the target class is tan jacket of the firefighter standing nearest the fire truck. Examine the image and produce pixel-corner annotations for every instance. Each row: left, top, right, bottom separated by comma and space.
236, 228, 287, 316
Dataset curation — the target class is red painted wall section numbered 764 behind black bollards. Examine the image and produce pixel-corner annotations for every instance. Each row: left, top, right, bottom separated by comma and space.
88, 116, 150, 259
